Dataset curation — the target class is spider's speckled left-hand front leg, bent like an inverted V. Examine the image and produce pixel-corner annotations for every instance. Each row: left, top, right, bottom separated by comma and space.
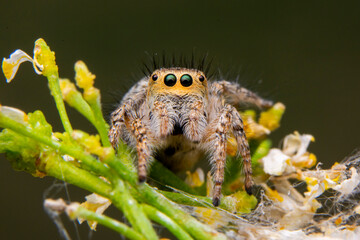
109, 100, 151, 182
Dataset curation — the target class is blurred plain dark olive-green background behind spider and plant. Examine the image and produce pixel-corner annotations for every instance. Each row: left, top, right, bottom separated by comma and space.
0, 0, 360, 239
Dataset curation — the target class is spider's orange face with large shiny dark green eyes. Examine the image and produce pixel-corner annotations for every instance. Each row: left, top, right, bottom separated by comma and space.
148, 68, 207, 97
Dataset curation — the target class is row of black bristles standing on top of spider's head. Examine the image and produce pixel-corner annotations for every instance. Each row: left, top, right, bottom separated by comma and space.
142, 51, 213, 78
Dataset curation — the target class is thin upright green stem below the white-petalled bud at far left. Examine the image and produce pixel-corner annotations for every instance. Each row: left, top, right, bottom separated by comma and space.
46, 72, 73, 134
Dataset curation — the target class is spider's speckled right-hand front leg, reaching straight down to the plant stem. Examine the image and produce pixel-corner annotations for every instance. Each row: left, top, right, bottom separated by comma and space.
204, 105, 232, 206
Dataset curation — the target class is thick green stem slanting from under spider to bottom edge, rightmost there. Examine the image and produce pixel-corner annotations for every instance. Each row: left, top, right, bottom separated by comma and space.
138, 183, 226, 240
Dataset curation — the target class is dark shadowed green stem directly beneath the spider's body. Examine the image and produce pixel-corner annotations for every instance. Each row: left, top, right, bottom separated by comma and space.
150, 161, 198, 194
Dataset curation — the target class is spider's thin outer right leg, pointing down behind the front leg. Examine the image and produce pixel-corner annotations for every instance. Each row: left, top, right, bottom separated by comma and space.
231, 107, 253, 195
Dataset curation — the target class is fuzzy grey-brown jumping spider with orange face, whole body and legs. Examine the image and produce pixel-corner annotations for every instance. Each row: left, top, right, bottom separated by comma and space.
109, 68, 272, 206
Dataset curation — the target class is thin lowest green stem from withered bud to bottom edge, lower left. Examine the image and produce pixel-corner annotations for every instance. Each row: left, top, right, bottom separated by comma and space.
71, 207, 146, 240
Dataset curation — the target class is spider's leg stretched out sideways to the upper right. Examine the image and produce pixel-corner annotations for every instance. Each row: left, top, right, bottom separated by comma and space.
212, 81, 274, 108
